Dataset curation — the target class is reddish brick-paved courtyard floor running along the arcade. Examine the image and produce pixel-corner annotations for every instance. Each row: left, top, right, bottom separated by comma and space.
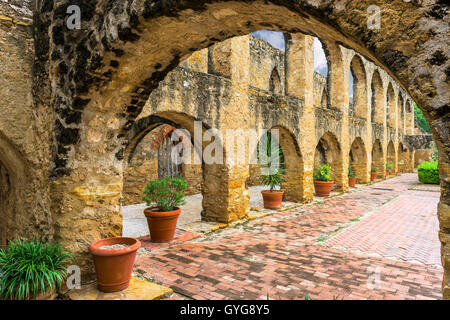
134, 174, 443, 300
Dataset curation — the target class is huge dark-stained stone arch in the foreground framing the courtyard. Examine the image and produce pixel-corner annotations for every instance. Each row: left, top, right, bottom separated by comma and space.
28, 0, 450, 298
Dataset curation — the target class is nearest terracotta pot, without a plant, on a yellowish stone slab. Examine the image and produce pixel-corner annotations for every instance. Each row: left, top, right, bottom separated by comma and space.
89, 237, 141, 292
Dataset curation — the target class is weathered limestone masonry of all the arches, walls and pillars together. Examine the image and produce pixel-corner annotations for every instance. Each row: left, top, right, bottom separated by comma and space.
0, 0, 450, 299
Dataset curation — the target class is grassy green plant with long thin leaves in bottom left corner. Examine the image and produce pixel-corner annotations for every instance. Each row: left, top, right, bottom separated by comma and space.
0, 239, 74, 300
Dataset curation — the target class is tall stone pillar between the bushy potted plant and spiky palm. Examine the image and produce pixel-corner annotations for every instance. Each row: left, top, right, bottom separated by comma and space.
203, 35, 252, 223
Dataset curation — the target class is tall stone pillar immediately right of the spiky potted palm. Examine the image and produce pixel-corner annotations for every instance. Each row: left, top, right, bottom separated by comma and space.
285, 33, 316, 202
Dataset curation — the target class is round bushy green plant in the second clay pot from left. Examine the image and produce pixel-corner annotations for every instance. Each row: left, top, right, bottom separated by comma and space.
142, 176, 187, 212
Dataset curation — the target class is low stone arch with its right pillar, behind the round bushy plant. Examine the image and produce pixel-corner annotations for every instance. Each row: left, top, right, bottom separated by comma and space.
125, 112, 241, 223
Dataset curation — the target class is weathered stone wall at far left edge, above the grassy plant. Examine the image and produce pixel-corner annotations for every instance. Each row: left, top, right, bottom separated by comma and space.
0, 0, 54, 245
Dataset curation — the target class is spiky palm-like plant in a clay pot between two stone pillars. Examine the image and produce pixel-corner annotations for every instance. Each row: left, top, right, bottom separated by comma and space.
259, 134, 285, 191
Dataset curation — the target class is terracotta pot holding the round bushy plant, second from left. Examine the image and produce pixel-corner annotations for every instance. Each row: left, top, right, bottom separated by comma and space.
144, 207, 181, 242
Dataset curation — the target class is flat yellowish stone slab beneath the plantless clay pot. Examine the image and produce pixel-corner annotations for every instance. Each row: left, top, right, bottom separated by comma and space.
67, 277, 173, 300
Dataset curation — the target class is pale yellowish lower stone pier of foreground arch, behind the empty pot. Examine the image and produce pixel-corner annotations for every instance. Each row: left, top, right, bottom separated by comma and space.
51, 110, 123, 281
